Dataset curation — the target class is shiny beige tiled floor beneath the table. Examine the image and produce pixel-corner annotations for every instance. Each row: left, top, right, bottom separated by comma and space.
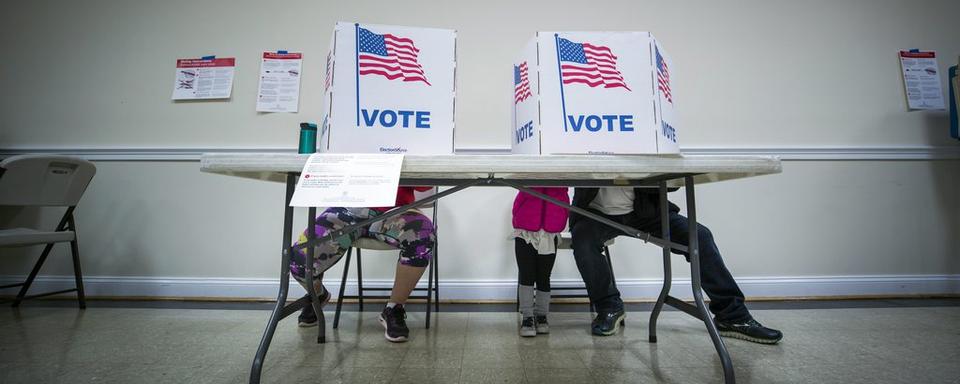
0, 306, 960, 384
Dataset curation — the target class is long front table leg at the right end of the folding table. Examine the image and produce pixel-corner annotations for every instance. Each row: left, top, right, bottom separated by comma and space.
684, 176, 736, 384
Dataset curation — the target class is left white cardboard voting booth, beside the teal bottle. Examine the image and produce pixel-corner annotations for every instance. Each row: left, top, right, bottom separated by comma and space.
317, 22, 456, 154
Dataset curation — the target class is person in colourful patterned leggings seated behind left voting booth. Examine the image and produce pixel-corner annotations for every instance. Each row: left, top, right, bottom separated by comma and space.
290, 187, 436, 343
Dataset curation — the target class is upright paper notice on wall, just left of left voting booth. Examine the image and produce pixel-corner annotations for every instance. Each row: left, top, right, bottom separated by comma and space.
257, 51, 303, 112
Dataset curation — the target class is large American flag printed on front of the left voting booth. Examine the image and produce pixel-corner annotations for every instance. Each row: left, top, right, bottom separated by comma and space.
357, 28, 430, 85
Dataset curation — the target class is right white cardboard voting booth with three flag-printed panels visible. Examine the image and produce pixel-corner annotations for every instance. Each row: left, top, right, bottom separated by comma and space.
512, 32, 680, 154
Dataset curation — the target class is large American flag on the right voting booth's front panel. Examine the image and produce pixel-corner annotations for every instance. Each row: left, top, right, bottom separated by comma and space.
558, 38, 630, 91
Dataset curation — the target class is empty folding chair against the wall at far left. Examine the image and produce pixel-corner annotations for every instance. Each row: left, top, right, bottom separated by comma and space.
0, 155, 97, 309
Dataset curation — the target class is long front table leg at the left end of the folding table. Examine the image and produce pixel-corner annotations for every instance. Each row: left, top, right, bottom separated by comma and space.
250, 173, 297, 384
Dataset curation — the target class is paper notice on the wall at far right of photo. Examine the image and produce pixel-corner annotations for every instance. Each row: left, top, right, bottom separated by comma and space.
900, 49, 945, 109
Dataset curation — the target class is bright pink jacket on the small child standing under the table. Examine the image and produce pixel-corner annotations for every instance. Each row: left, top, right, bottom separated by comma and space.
513, 187, 570, 232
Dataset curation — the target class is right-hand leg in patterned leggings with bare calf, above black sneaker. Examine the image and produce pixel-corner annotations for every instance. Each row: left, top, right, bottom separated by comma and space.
369, 211, 436, 304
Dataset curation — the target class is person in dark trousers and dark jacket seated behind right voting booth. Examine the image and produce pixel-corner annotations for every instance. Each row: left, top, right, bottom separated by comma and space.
570, 187, 783, 344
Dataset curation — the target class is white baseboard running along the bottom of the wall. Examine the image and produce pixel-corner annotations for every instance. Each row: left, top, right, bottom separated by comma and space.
0, 275, 960, 301
